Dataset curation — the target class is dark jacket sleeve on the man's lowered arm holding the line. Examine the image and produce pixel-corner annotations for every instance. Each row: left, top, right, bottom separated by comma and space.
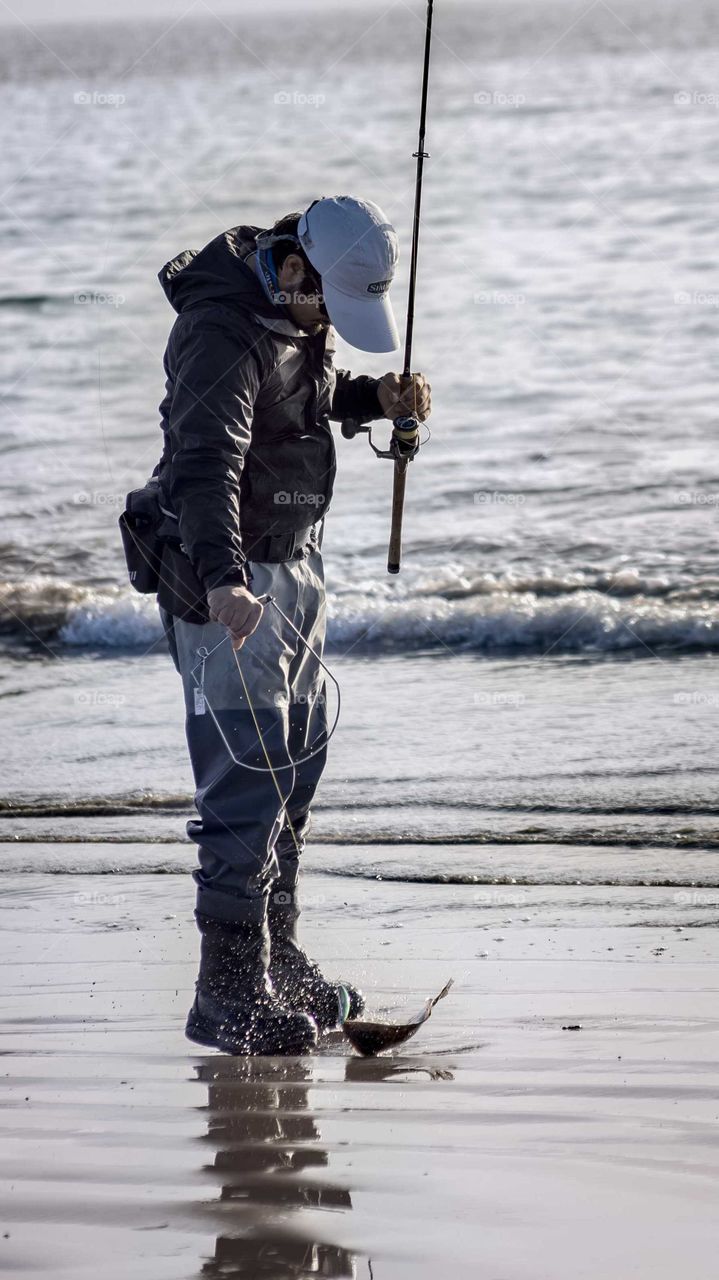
163, 316, 261, 591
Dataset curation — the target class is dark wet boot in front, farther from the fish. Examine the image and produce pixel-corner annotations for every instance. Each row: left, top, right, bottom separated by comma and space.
186, 913, 317, 1055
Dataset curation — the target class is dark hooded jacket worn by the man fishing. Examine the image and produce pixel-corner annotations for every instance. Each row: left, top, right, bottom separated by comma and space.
157, 227, 381, 591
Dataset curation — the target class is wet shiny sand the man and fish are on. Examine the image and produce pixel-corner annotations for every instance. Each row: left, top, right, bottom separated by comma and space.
0, 873, 719, 1280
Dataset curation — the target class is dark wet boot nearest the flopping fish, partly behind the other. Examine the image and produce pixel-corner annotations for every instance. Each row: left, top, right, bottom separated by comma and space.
267, 890, 365, 1030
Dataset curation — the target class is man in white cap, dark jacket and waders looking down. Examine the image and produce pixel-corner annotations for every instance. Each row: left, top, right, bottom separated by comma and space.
157, 196, 430, 1053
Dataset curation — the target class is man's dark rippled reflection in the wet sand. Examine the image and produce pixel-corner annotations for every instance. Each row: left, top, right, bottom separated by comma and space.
196, 1057, 357, 1280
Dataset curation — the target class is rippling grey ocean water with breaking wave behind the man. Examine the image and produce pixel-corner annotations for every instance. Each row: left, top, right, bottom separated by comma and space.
0, 0, 719, 884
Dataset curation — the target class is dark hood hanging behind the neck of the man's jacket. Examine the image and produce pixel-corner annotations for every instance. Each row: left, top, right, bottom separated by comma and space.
157, 227, 278, 320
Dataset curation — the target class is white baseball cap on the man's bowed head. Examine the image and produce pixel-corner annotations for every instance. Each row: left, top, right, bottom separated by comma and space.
297, 196, 399, 351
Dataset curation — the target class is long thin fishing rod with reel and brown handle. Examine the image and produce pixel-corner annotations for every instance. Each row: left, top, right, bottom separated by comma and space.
342, 0, 434, 573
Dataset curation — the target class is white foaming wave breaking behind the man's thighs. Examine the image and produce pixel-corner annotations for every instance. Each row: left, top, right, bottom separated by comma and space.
0, 571, 719, 655
